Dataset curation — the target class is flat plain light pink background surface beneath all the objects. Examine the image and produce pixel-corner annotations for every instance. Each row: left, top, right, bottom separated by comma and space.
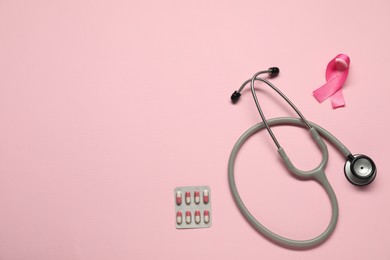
0, 0, 390, 260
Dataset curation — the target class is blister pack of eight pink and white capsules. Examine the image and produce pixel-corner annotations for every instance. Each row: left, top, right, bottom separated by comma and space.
174, 186, 211, 229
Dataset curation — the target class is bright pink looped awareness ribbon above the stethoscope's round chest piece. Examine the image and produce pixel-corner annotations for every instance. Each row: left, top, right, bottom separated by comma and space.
313, 54, 351, 108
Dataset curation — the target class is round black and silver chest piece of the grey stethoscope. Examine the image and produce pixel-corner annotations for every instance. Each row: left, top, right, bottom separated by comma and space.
344, 154, 376, 186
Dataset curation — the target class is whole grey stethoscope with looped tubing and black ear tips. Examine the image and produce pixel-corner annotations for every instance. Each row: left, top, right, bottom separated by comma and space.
228, 67, 376, 249
